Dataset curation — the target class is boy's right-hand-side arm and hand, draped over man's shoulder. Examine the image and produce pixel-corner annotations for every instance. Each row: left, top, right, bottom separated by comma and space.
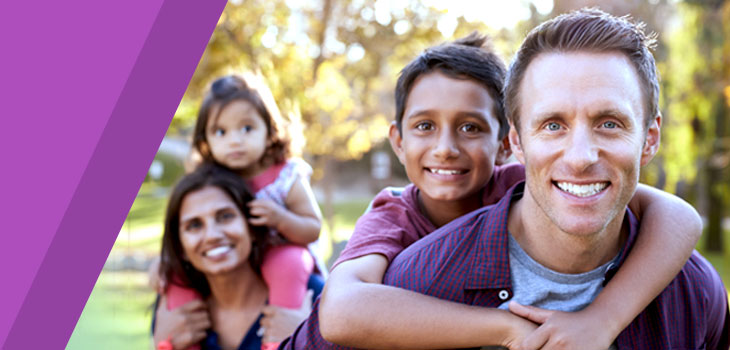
510, 184, 702, 349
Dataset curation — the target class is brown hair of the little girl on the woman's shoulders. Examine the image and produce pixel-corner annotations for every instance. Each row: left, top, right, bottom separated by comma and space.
193, 75, 290, 168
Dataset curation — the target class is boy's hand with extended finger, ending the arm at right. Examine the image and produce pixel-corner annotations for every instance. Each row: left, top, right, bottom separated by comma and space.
509, 301, 613, 350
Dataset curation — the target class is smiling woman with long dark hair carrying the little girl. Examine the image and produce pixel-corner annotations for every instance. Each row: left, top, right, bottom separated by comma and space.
153, 165, 322, 350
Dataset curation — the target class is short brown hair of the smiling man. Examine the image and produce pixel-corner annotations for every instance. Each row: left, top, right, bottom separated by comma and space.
504, 8, 659, 131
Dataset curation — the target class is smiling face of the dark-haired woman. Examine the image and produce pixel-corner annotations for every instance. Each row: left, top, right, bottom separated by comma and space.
180, 186, 251, 276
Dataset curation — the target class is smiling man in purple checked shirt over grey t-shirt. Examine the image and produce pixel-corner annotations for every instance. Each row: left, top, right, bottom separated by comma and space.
384, 10, 730, 349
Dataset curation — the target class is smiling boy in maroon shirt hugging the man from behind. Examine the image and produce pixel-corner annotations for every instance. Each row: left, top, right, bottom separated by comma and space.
280, 34, 701, 349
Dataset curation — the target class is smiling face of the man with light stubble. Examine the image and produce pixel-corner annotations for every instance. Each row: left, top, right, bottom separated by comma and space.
510, 52, 661, 235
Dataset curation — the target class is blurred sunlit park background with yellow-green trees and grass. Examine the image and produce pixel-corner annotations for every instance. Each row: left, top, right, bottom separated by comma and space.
67, 0, 730, 349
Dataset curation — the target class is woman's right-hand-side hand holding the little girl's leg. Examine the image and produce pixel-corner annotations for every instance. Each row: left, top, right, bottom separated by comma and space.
261, 289, 314, 344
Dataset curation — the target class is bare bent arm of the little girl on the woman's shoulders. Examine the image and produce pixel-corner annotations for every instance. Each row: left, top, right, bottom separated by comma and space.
249, 178, 322, 245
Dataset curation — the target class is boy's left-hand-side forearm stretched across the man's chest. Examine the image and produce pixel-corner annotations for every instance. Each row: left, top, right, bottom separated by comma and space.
319, 254, 535, 349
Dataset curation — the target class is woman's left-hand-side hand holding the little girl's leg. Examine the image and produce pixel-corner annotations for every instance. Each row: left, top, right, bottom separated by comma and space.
154, 295, 210, 350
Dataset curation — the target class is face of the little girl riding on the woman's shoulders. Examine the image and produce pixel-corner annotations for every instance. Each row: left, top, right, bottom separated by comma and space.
206, 100, 270, 173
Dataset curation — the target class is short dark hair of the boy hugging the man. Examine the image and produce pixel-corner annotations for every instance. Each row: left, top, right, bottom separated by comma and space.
395, 32, 509, 140
